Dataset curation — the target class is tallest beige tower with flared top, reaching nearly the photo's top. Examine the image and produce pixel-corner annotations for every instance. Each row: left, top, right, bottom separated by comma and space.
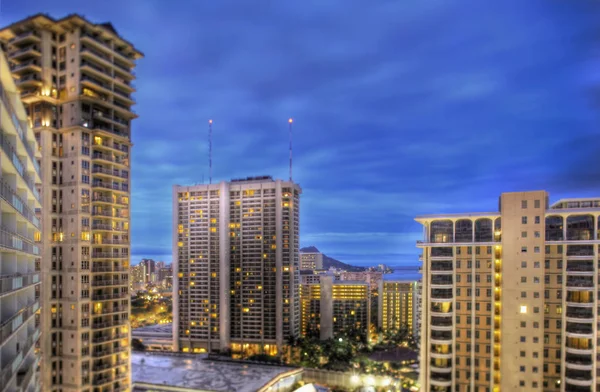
0, 14, 142, 392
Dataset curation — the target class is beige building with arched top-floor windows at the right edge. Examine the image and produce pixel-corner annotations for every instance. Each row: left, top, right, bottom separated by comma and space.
417, 191, 600, 391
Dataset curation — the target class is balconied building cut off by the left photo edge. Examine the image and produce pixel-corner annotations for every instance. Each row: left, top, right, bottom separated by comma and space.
0, 45, 41, 392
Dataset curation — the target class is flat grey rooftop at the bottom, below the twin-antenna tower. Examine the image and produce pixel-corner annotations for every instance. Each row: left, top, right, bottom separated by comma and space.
131, 352, 294, 392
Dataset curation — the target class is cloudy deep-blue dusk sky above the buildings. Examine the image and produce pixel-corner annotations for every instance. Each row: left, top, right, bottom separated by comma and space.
0, 0, 600, 265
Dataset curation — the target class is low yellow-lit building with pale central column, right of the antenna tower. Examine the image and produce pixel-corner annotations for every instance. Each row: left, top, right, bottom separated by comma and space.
300, 274, 371, 341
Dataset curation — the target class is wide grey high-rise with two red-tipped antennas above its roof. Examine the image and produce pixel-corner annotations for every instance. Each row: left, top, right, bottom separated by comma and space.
173, 177, 301, 355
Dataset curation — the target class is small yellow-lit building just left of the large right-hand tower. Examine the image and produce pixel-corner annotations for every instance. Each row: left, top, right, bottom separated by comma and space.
377, 280, 419, 334
